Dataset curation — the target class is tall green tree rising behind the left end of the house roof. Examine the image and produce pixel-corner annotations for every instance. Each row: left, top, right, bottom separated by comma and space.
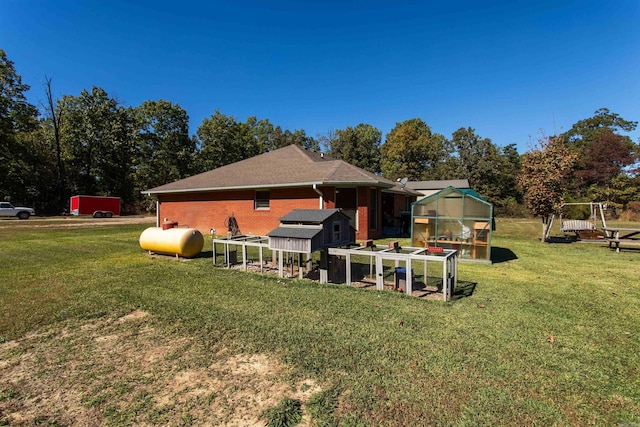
134, 100, 196, 201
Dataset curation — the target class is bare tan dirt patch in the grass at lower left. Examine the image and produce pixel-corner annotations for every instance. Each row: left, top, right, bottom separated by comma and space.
0, 310, 320, 426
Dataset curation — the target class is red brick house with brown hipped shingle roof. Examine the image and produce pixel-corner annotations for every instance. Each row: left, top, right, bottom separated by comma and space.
144, 145, 419, 240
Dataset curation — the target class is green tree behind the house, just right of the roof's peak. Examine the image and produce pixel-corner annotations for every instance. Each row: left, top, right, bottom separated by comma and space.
329, 123, 382, 173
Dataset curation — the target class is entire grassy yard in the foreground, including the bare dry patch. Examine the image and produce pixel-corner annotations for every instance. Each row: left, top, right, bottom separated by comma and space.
0, 219, 640, 426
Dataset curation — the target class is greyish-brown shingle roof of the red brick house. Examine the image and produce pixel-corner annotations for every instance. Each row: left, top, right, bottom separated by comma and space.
144, 144, 394, 194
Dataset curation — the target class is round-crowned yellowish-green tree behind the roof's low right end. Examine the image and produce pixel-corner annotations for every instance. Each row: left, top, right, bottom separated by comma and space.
380, 118, 449, 180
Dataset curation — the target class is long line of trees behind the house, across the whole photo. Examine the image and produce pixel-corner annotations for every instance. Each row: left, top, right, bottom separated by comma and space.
0, 50, 640, 215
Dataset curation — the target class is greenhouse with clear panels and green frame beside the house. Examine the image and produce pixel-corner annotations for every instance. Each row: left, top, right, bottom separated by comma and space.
411, 187, 493, 263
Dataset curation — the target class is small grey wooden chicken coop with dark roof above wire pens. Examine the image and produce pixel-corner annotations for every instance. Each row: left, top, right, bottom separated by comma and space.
267, 209, 356, 254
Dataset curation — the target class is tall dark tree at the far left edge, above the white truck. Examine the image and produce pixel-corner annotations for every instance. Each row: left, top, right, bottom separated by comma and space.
0, 49, 38, 202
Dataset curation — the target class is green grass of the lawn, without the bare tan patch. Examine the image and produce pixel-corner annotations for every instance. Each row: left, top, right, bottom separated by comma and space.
0, 219, 640, 426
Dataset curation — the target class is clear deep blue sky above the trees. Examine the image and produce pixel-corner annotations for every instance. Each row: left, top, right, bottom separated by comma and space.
0, 0, 640, 153
